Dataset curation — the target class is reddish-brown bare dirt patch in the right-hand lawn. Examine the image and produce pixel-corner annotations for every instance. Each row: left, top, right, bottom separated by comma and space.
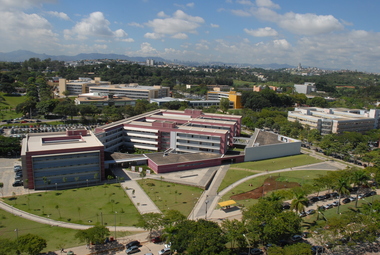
231, 177, 301, 200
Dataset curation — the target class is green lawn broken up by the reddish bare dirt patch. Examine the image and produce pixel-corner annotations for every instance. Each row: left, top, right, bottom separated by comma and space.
220, 170, 328, 207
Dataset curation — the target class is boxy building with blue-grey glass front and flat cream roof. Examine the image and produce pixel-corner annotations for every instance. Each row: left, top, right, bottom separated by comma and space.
21, 129, 104, 189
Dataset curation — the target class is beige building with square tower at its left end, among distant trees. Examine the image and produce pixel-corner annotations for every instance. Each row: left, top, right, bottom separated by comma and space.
58, 77, 111, 96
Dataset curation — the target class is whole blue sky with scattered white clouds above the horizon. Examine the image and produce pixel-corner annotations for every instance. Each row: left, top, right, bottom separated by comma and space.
0, 0, 380, 73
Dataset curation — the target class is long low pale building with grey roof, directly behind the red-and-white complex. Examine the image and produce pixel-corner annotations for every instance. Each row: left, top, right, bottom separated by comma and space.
90, 83, 170, 100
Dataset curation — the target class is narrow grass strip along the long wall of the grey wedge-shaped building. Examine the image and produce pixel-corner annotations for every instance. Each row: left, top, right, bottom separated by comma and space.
230, 154, 322, 171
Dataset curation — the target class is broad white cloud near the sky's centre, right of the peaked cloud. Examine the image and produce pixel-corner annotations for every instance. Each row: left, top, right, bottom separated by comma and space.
145, 10, 204, 38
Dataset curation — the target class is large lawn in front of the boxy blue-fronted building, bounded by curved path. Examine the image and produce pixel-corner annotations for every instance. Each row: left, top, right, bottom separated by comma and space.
4, 184, 139, 226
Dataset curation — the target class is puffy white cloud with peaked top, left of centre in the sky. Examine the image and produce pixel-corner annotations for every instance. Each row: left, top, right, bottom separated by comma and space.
64, 12, 128, 40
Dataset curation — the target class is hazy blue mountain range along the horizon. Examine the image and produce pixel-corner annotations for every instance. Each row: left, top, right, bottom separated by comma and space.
0, 50, 294, 69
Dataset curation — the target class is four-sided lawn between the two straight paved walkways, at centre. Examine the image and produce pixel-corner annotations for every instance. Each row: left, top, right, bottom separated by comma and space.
137, 179, 203, 216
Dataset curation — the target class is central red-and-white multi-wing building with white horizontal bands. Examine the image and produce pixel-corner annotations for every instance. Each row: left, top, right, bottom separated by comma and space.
95, 109, 241, 154
